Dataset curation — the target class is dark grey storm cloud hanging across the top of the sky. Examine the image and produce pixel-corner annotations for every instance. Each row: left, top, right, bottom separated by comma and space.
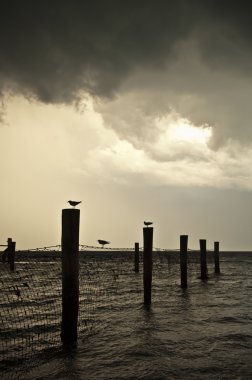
0, 0, 252, 102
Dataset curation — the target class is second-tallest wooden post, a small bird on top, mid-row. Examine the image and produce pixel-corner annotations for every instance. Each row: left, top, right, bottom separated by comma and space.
143, 227, 153, 305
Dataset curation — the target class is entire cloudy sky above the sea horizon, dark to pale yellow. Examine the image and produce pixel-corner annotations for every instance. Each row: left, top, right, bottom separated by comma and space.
0, 0, 252, 250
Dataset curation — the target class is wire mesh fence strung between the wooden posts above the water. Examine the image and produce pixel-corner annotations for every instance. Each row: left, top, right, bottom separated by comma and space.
0, 246, 215, 378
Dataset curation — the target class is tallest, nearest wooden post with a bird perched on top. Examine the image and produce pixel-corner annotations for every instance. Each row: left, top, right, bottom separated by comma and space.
61, 209, 80, 345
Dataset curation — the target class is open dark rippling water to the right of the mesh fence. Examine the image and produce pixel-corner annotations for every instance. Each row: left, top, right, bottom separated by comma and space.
2, 253, 252, 380
